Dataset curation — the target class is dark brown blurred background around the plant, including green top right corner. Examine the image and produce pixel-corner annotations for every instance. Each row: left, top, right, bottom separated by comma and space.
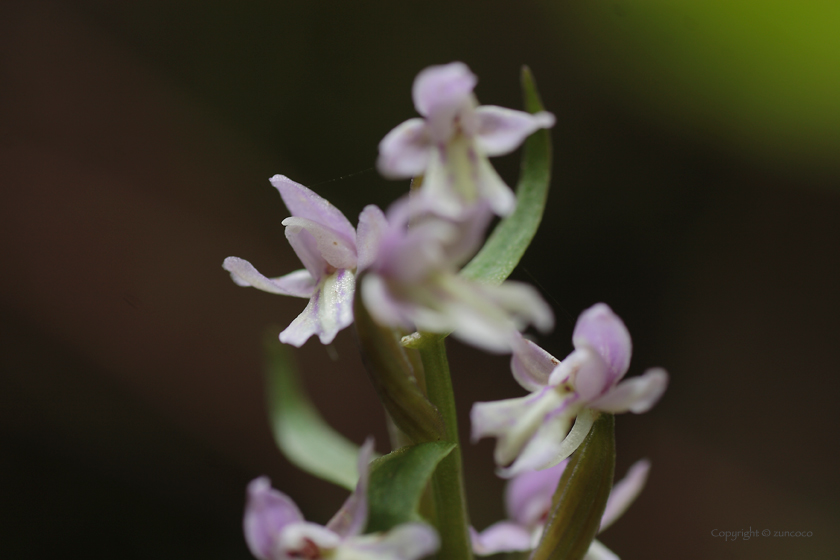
0, 0, 840, 560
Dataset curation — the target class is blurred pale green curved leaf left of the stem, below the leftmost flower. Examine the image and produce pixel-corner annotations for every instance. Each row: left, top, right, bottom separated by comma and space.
265, 336, 359, 490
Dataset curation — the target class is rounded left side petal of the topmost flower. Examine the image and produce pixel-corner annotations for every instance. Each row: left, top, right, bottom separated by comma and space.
376, 119, 432, 179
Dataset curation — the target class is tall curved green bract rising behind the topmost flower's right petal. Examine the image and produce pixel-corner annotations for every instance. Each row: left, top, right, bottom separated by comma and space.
461, 66, 551, 284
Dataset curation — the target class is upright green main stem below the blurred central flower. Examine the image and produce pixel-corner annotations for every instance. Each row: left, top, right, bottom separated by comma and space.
419, 339, 472, 560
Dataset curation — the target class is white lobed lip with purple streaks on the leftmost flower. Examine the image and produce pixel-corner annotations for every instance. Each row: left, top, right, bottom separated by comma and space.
280, 269, 355, 347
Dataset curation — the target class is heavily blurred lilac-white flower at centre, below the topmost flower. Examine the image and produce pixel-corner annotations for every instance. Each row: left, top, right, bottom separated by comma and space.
359, 197, 554, 352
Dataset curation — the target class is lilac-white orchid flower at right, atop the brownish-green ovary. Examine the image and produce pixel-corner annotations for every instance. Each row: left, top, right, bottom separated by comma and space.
470, 303, 668, 478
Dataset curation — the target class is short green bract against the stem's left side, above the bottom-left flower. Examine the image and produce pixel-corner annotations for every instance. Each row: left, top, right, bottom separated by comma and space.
366, 441, 456, 533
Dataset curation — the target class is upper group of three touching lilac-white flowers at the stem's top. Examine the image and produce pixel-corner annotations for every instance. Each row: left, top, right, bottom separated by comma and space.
224, 62, 554, 352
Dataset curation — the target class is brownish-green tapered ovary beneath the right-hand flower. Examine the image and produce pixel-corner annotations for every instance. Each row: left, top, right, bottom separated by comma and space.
531, 414, 615, 560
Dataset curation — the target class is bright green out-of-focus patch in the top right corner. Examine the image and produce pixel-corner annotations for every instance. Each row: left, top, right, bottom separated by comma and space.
544, 0, 840, 168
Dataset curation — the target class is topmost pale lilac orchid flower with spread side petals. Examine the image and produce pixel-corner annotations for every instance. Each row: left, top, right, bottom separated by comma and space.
377, 62, 554, 219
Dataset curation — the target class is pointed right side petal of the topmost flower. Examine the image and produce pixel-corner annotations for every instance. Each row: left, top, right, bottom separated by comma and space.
475, 105, 555, 157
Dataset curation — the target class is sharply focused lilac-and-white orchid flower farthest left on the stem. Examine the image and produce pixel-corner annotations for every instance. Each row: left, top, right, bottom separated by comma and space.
222, 175, 357, 347
